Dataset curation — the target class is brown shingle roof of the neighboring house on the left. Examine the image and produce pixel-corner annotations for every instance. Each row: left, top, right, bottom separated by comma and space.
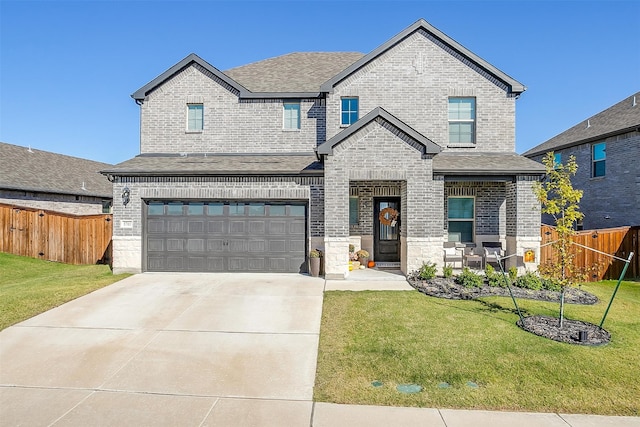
0, 142, 113, 199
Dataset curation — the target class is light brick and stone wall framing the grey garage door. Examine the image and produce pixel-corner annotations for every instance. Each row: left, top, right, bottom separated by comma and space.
113, 177, 324, 273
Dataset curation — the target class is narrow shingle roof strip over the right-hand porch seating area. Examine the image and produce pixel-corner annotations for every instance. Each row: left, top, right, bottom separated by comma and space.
433, 151, 545, 176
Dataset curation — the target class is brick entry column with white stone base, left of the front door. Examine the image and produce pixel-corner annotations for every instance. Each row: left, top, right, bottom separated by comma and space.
324, 156, 349, 280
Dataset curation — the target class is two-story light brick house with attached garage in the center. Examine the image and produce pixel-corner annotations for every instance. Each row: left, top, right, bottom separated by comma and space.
103, 20, 544, 278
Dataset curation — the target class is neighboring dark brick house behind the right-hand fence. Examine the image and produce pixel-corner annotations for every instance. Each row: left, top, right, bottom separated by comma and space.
524, 92, 640, 230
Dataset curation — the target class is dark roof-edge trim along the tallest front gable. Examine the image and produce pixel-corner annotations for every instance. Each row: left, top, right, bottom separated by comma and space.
321, 19, 526, 95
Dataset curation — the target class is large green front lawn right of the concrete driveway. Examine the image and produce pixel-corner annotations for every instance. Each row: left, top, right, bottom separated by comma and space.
314, 282, 640, 416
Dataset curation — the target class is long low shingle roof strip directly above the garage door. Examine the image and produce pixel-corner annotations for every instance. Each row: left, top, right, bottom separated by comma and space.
102, 153, 322, 176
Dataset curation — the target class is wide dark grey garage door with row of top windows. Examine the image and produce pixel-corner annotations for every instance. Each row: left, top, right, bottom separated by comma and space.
145, 201, 306, 273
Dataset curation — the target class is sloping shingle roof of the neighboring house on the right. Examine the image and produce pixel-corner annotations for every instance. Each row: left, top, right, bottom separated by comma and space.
524, 92, 640, 156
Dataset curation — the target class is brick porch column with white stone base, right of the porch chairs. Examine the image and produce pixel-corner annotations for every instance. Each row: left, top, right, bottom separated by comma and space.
506, 176, 541, 273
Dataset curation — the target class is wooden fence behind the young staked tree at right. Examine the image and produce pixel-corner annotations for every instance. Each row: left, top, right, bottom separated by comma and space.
540, 225, 640, 281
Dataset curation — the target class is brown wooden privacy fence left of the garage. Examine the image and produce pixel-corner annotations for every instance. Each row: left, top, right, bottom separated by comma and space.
0, 203, 113, 264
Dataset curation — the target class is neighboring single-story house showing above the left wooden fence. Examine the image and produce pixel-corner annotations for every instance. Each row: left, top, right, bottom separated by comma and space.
0, 142, 113, 215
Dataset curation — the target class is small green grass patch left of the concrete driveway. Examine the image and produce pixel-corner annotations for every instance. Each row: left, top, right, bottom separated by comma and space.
0, 252, 129, 330
